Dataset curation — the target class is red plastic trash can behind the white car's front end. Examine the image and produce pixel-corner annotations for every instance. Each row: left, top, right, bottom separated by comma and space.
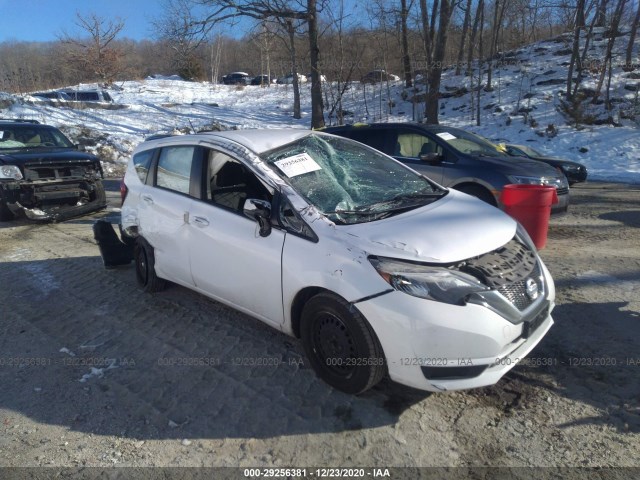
500, 184, 558, 250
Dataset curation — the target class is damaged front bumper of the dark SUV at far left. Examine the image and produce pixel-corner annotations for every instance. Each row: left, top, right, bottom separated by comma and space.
0, 178, 107, 222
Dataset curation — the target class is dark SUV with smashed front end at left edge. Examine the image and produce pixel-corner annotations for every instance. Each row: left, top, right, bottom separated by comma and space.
0, 119, 106, 221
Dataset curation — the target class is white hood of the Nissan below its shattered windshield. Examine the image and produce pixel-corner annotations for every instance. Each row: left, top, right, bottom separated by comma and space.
336, 190, 517, 263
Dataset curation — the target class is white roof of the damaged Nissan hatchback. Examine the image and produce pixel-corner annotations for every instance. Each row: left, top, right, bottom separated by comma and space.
150, 128, 314, 153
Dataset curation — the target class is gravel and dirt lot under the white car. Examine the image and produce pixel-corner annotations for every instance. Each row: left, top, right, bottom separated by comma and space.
0, 181, 640, 467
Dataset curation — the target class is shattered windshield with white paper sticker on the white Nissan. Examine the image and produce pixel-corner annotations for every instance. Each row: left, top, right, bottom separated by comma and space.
264, 135, 446, 224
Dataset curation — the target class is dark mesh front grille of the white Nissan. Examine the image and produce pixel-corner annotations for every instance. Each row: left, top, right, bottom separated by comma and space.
459, 238, 543, 310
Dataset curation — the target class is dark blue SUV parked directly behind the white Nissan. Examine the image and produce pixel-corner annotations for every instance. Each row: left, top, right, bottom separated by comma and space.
324, 123, 569, 213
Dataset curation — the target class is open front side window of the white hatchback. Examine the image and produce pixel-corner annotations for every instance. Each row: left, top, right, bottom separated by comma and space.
206, 150, 273, 213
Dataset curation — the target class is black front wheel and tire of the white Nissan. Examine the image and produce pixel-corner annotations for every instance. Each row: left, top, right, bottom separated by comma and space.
300, 293, 387, 394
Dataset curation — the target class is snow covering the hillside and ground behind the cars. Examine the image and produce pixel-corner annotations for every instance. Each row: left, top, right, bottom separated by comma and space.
0, 27, 640, 183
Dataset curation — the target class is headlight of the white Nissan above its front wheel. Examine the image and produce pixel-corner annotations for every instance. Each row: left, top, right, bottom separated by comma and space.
369, 257, 490, 305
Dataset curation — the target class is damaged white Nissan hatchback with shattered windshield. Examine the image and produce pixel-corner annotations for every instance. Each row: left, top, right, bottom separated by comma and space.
122, 129, 555, 393
